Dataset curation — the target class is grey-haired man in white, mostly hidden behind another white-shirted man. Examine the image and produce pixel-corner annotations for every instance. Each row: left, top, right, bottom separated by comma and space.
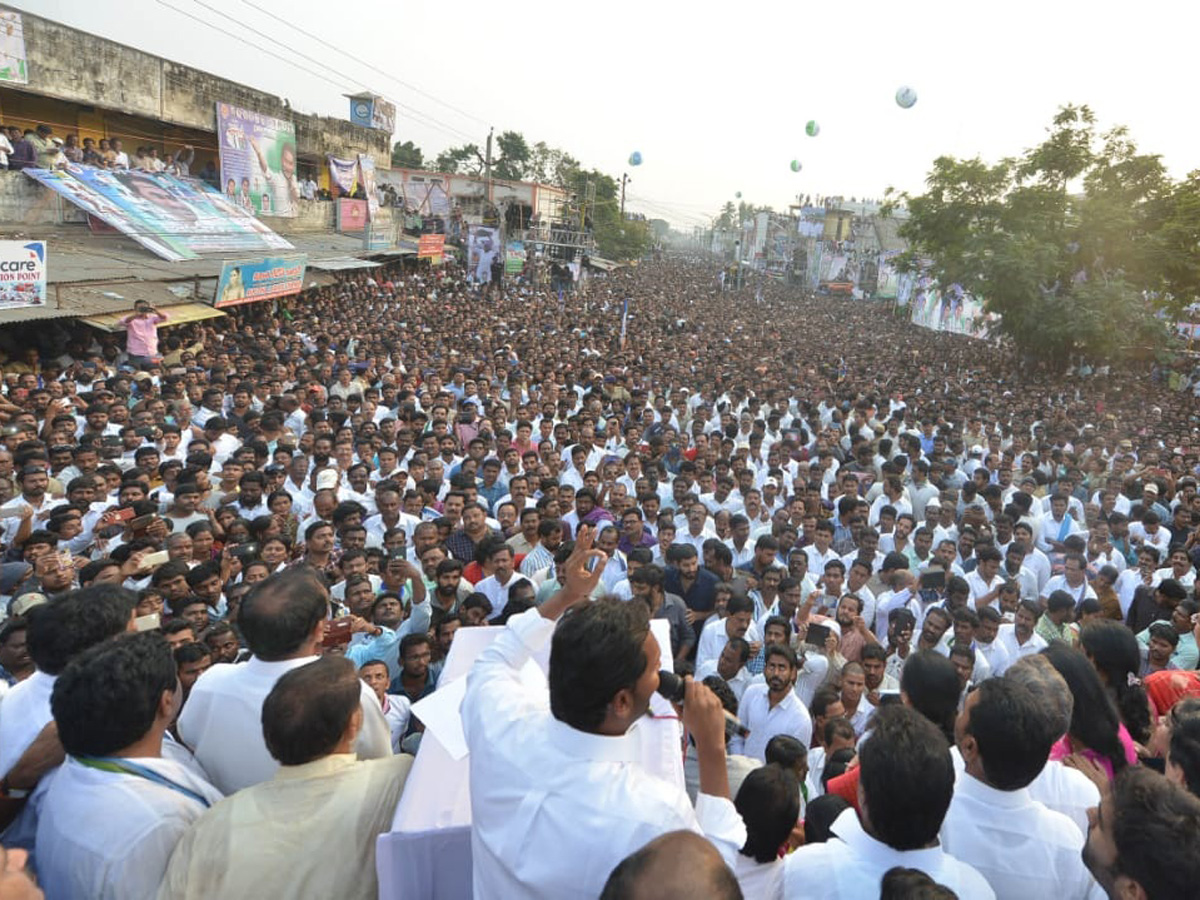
1004, 654, 1100, 838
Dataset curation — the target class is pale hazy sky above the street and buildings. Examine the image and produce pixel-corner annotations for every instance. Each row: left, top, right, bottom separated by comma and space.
12, 0, 1200, 230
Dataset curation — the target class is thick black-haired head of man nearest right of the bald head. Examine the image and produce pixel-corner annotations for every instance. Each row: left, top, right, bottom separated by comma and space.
859, 707, 954, 850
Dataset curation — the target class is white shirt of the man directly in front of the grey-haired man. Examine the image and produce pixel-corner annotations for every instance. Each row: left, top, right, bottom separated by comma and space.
940, 773, 1103, 900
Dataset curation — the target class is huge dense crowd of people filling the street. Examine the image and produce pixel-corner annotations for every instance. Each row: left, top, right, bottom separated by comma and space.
0, 257, 1200, 900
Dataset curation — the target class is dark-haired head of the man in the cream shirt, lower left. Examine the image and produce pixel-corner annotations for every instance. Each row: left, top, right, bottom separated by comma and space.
263, 656, 362, 766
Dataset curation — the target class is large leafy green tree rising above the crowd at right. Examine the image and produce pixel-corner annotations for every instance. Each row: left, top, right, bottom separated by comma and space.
884, 106, 1171, 365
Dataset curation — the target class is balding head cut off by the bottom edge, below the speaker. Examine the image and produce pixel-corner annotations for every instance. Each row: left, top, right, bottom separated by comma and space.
600, 832, 742, 900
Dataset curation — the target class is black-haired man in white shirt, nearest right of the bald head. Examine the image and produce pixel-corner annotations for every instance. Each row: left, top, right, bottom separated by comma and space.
784, 707, 995, 900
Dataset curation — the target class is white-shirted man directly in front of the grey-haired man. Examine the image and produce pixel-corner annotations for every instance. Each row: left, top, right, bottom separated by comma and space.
941, 678, 1096, 900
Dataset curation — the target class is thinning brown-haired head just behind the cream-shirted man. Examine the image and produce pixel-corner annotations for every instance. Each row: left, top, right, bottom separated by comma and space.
238, 568, 329, 662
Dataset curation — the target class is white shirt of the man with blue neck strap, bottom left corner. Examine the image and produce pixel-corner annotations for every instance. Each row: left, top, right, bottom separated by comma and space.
37, 757, 221, 900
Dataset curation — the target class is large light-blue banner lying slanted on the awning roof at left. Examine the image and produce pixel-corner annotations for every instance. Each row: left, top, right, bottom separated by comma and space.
23, 164, 292, 262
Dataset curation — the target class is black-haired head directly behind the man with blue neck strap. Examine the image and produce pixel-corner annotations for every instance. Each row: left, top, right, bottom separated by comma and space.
26, 584, 137, 674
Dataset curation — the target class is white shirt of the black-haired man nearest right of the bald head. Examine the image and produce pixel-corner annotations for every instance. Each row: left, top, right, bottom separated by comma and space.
784, 809, 993, 900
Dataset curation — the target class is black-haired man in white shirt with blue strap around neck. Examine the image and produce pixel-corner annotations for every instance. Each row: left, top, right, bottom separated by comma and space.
37, 632, 221, 900
